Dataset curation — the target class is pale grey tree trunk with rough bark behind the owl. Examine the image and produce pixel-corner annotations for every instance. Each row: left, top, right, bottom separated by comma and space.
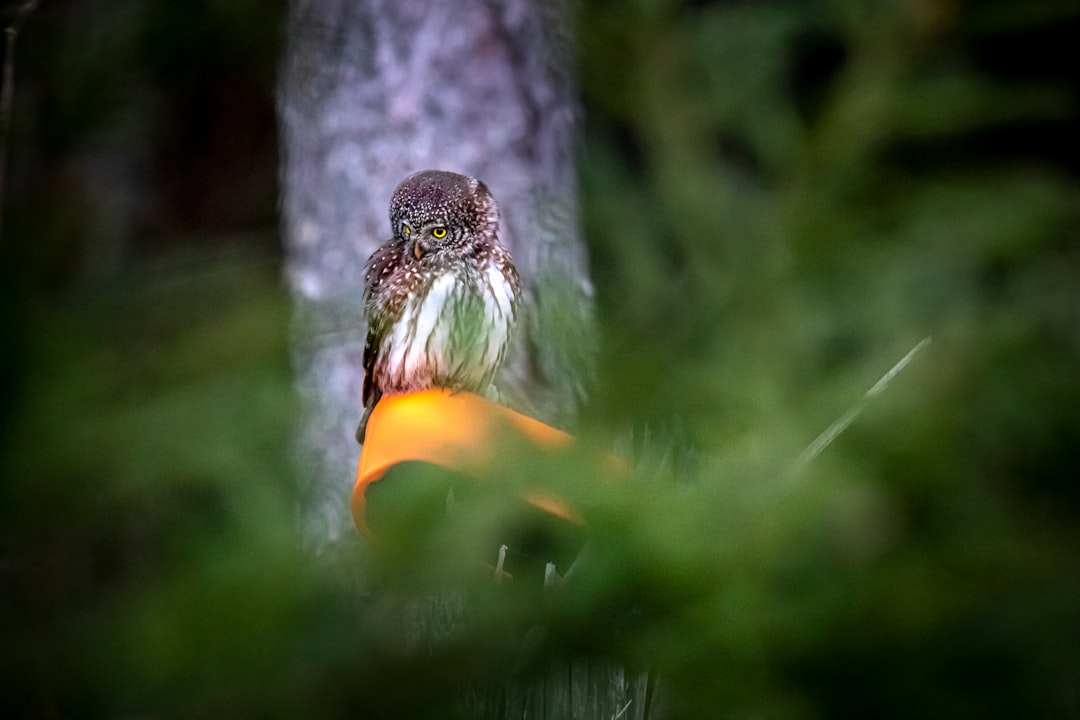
279, 0, 591, 544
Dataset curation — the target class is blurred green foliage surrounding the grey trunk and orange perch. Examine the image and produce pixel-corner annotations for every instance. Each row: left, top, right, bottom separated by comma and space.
0, 0, 1080, 718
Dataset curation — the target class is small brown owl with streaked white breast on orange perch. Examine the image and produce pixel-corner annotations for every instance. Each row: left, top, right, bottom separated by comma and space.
356, 171, 521, 443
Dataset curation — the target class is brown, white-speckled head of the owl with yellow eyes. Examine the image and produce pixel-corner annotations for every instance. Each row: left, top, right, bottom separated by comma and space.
390, 169, 499, 260
